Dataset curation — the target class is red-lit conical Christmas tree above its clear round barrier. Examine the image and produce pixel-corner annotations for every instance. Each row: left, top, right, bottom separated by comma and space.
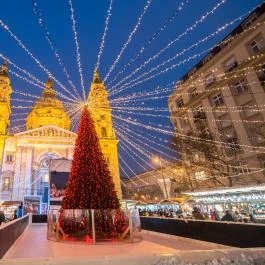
62, 107, 120, 209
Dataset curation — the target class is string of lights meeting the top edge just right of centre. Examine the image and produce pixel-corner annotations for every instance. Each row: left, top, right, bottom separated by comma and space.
103, 0, 152, 83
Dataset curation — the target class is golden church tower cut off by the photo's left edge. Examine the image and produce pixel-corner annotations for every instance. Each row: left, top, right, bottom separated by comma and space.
0, 62, 12, 168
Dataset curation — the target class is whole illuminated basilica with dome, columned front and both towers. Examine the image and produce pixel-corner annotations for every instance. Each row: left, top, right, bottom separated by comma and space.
0, 63, 121, 204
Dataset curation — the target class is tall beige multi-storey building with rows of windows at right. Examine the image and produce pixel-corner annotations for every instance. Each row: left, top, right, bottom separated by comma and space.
168, 4, 265, 189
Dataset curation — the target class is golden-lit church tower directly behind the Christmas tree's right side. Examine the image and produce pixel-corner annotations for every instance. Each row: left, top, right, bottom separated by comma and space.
88, 71, 121, 199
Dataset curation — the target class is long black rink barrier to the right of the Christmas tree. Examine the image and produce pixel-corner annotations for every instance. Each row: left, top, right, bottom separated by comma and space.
140, 216, 265, 248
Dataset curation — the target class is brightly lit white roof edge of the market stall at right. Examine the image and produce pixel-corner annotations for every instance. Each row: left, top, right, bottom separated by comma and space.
184, 185, 265, 196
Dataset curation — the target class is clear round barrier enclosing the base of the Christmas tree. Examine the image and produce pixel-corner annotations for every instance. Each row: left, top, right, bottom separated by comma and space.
47, 209, 142, 244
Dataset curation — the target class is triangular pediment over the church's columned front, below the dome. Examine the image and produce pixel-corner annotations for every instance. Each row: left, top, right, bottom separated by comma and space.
15, 125, 76, 138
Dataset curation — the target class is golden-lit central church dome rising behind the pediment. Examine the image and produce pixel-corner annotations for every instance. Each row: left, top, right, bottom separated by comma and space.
26, 78, 71, 130
